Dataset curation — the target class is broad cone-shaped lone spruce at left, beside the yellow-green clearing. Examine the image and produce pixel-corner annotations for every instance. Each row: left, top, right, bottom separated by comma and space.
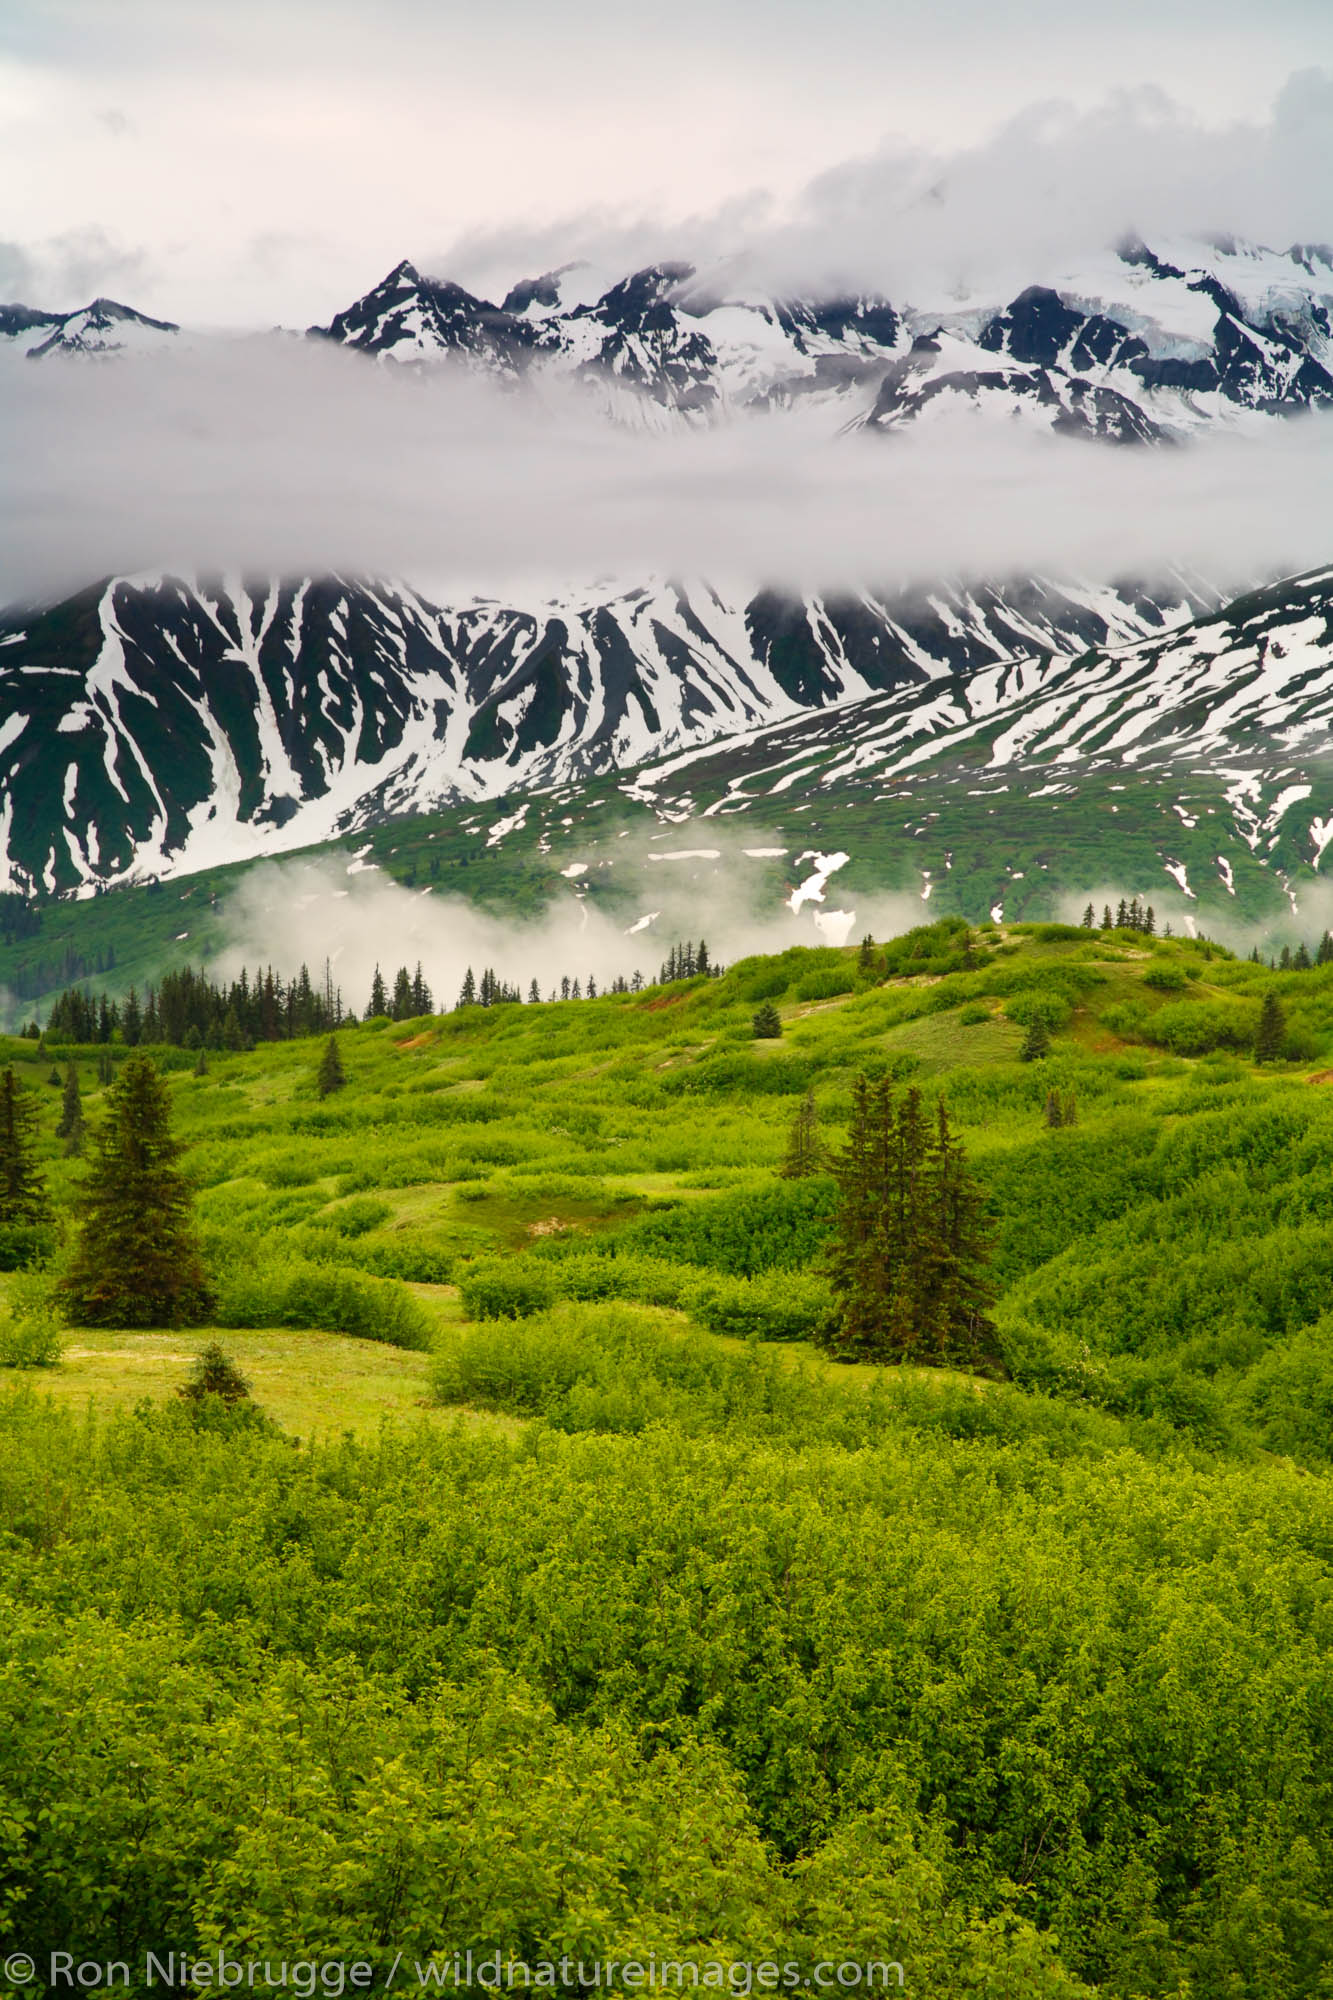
60, 1056, 212, 1326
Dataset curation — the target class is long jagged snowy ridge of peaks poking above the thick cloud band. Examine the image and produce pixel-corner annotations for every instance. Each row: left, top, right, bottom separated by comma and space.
310, 242, 1333, 444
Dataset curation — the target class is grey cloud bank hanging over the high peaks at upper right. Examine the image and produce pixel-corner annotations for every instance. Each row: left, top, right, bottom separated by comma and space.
440, 68, 1333, 306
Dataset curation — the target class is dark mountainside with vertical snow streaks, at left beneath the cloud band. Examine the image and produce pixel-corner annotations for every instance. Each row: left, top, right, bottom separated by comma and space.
0, 578, 1211, 892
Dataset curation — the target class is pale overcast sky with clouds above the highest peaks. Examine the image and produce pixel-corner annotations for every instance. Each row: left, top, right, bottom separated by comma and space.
0, 0, 1333, 326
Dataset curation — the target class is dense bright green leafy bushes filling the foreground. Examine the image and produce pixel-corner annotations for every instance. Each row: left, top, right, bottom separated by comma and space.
0, 1384, 1333, 2000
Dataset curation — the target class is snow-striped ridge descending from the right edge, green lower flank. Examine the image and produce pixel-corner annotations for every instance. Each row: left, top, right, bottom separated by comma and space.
612, 568, 1333, 928
